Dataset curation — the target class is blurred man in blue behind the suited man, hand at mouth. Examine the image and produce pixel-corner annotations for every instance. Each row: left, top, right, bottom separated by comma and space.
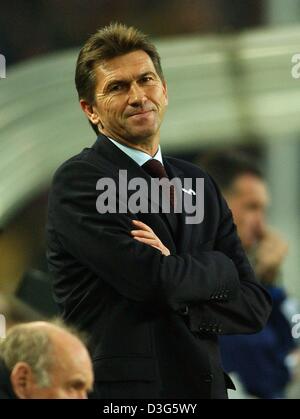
201, 150, 296, 398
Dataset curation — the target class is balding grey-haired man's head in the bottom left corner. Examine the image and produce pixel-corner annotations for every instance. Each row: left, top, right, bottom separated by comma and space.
0, 322, 93, 399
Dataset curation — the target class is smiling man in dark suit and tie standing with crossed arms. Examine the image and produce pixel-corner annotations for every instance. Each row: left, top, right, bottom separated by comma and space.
48, 24, 271, 398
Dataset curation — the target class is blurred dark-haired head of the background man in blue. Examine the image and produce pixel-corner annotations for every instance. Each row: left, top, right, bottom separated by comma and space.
201, 150, 268, 253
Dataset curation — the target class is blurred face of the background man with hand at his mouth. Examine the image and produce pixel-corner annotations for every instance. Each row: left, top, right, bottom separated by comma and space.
226, 174, 269, 250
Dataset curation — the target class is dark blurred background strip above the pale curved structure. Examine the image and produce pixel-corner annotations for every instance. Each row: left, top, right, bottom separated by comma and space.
0, 0, 266, 65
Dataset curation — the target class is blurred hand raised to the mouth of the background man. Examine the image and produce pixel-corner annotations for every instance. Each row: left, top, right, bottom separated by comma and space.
255, 228, 288, 282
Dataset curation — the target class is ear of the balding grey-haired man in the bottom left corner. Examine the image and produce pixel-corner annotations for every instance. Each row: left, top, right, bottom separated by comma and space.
10, 362, 33, 399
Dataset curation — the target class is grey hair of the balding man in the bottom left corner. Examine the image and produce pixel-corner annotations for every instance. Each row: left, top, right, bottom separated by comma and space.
0, 320, 85, 388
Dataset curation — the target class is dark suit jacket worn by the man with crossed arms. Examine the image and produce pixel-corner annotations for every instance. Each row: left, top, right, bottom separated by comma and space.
47, 135, 271, 398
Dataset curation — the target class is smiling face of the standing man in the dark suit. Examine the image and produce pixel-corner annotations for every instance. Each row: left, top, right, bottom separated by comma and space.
85, 50, 168, 144
